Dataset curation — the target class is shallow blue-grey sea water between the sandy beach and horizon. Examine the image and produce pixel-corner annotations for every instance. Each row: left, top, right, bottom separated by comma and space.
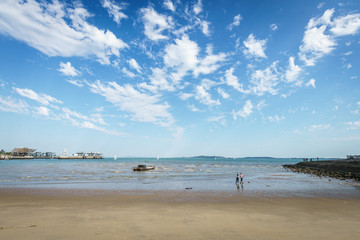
0, 158, 360, 198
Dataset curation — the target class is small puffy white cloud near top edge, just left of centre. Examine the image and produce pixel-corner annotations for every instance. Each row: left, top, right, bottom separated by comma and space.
140, 6, 173, 41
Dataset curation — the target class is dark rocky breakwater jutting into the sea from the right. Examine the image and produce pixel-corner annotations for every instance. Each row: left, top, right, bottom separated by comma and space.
283, 159, 360, 181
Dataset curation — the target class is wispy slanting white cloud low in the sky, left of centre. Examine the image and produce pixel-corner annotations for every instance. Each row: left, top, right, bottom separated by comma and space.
88, 80, 174, 127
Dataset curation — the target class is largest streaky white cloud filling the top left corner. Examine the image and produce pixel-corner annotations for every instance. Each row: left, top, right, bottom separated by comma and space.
0, 0, 127, 64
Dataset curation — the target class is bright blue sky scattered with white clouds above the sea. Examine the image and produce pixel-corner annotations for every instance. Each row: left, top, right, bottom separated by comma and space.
0, 0, 360, 157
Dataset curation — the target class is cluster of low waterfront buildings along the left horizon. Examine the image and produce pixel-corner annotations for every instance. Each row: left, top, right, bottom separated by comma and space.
0, 147, 104, 160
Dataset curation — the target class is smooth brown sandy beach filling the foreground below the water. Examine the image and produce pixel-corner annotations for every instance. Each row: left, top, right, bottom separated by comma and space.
0, 190, 360, 240
